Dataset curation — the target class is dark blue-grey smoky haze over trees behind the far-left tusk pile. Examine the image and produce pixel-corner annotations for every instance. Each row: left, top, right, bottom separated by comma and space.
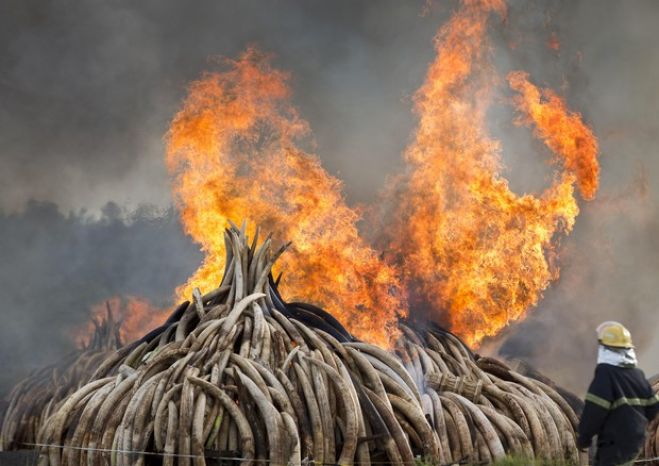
0, 202, 201, 394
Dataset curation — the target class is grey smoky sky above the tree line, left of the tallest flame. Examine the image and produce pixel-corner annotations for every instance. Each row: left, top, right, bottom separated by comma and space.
0, 0, 445, 210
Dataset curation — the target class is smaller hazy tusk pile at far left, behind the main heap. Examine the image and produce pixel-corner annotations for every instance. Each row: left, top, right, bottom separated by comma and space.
0, 305, 122, 451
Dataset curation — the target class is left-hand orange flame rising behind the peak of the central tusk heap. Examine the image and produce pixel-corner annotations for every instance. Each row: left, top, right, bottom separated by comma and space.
167, 49, 406, 345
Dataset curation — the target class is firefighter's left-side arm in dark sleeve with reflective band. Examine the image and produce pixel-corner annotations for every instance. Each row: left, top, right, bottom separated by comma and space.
577, 366, 613, 449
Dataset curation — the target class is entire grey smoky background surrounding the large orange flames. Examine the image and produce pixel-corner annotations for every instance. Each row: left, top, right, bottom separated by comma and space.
0, 0, 659, 391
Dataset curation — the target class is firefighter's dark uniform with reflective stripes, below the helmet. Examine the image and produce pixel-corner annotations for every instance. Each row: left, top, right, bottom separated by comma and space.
577, 364, 659, 466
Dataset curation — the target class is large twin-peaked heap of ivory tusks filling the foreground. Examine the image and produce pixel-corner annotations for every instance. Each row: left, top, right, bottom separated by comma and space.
31, 226, 583, 466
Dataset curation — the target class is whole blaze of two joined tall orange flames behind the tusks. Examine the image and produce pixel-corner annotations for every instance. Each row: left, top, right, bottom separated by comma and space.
159, 0, 599, 345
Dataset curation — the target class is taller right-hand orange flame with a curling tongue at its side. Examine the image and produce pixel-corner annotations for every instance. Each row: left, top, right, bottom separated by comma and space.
389, 2, 599, 345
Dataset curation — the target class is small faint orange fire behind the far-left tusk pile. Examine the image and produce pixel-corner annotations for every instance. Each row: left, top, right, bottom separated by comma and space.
74, 296, 168, 347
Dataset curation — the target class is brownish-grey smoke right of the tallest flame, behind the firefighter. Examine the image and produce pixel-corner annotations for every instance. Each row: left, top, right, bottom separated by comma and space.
498, 2, 659, 393
